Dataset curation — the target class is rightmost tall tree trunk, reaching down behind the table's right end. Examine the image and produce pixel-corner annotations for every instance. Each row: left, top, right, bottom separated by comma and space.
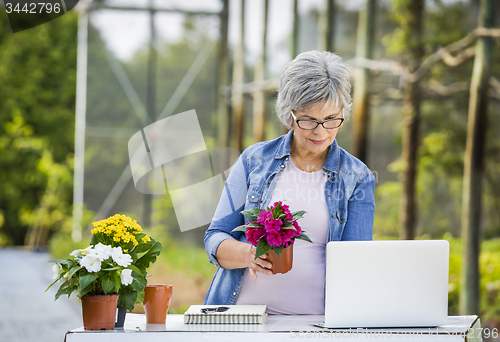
460, 0, 495, 315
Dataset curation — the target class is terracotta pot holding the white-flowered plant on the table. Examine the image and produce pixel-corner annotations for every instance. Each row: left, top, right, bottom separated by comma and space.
82, 295, 118, 330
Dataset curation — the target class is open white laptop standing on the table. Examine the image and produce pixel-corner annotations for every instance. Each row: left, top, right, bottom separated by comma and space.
318, 240, 450, 328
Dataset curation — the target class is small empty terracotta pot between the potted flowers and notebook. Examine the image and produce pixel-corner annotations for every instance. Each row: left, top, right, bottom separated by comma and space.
143, 285, 172, 324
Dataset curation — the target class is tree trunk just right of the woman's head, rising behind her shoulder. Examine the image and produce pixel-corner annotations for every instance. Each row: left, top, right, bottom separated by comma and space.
352, 0, 375, 164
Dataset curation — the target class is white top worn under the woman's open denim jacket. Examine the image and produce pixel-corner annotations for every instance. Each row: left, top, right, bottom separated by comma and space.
235, 161, 329, 315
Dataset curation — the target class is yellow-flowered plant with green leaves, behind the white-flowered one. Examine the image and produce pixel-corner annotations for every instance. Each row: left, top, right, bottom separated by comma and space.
90, 214, 162, 311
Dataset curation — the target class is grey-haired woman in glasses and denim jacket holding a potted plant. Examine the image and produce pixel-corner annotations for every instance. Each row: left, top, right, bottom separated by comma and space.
205, 51, 375, 314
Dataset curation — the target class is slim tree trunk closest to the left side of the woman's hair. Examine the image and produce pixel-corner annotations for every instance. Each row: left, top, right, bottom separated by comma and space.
253, 0, 269, 142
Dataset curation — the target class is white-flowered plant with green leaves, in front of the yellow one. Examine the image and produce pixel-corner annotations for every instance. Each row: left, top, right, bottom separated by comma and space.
46, 243, 147, 310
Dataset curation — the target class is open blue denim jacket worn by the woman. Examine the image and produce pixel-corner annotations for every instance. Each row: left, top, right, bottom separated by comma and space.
204, 131, 375, 305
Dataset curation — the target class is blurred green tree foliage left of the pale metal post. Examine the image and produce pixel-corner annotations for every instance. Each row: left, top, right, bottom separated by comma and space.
0, 13, 77, 245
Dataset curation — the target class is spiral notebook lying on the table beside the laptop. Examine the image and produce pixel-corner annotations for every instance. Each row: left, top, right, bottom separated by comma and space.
184, 305, 267, 324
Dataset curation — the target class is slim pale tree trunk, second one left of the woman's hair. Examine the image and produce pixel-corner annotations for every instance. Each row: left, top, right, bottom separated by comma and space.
231, 0, 245, 152
